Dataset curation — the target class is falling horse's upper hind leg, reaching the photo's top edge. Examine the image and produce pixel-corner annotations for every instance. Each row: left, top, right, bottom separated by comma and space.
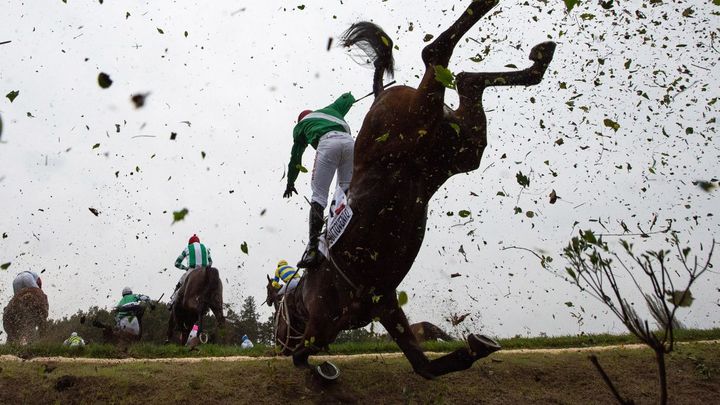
411, 0, 498, 116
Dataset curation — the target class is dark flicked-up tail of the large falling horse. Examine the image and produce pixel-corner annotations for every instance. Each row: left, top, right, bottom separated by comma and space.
340, 21, 395, 97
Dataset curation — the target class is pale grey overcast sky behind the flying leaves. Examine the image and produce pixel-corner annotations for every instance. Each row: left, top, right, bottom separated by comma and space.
0, 0, 720, 337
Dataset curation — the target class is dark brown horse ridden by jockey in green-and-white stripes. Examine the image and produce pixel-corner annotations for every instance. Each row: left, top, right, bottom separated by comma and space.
166, 267, 225, 344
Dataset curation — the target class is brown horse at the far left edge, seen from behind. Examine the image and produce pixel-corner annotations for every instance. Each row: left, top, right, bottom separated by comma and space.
3, 288, 49, 345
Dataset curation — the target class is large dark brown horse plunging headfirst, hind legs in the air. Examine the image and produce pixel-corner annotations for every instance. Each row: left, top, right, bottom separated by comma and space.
276, 0, 555, 378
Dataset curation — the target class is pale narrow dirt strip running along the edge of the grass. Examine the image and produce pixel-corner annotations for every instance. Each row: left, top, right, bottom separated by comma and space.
0, 340, 720, 364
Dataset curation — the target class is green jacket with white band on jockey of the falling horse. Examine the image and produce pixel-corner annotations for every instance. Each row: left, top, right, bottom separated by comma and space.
288, 93, 355, 186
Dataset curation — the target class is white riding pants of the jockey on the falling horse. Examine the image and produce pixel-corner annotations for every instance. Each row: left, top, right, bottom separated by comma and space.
311, 131, 355, 208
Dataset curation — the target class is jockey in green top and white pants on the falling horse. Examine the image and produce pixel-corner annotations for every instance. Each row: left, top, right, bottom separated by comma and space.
283, 92, 355, 268
